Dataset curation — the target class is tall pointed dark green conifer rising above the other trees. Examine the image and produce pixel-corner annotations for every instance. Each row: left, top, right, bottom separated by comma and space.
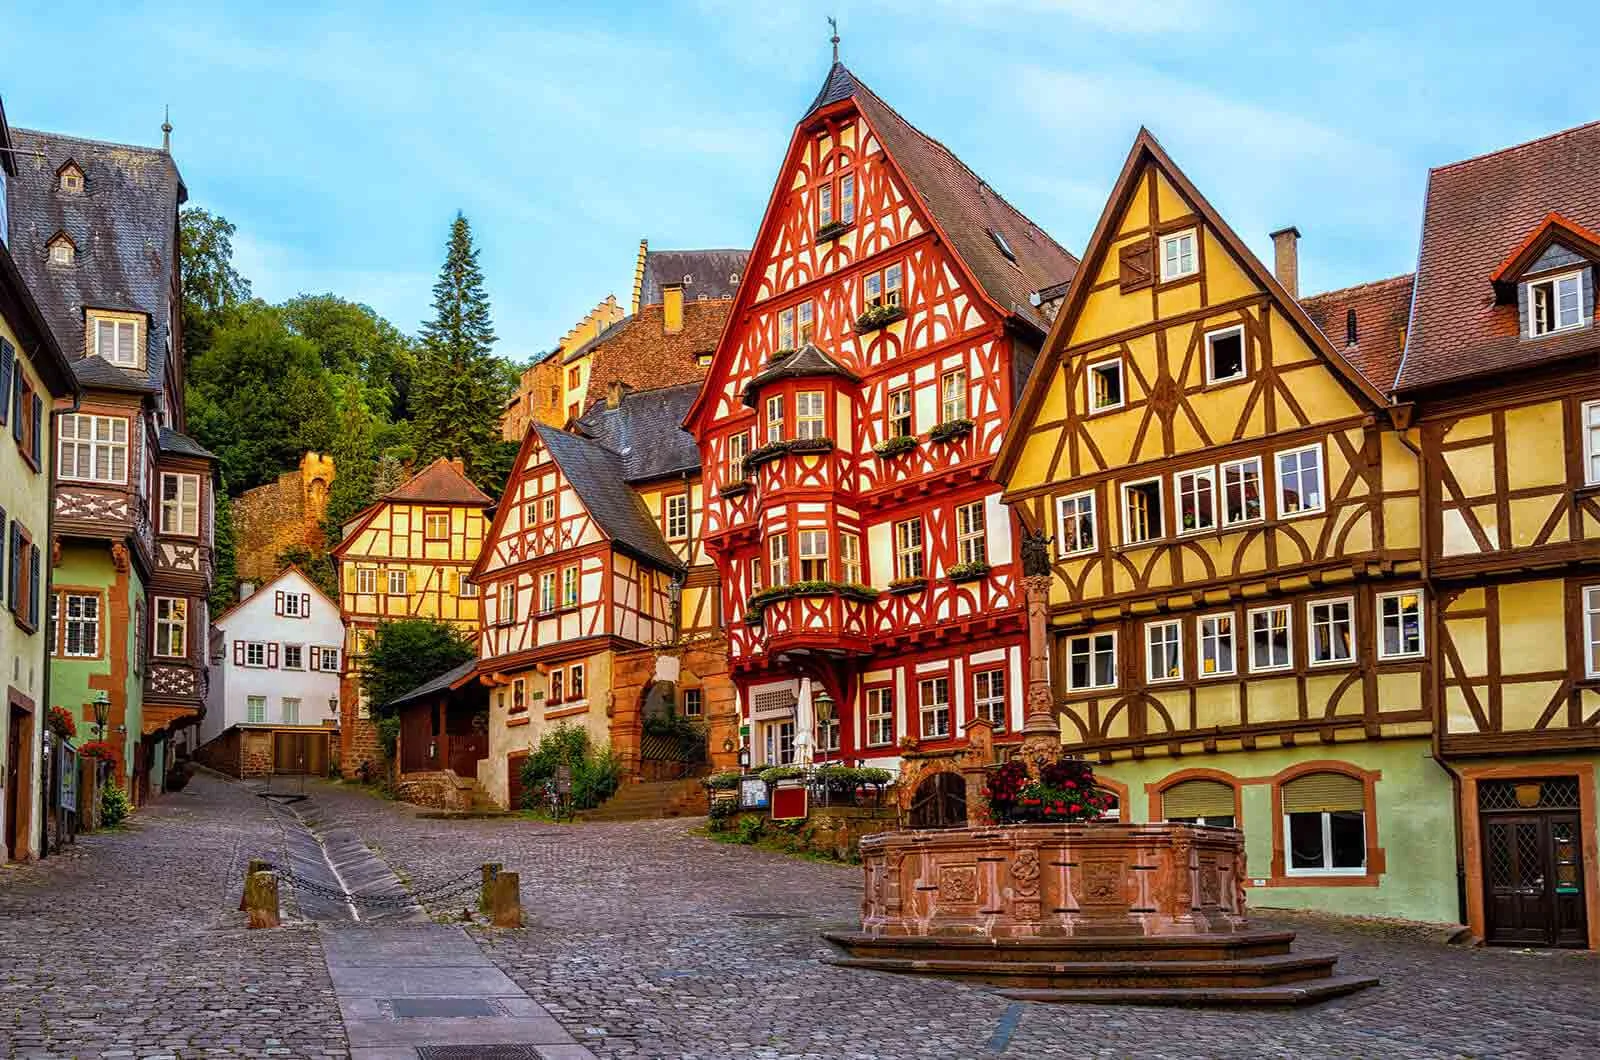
411, 213, 506, 476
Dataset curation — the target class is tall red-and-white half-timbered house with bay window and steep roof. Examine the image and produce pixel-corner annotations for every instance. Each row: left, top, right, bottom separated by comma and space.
686, 62, 1077, 764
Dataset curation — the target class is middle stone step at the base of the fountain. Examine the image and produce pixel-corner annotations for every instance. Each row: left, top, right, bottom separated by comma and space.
829, 954, 1339, 990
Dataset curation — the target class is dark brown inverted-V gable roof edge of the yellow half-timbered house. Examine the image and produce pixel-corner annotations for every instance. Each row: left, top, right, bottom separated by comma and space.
990, 126, 1387, 482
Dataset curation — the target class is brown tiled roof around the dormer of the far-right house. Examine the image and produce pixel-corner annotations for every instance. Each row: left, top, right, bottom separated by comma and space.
1395, 122, 1600, 391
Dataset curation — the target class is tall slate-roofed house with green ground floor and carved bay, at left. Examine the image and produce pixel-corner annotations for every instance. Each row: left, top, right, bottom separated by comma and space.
6, 122, 216, 799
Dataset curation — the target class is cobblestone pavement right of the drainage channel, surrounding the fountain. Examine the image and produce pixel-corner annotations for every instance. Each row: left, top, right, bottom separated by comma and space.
300, 786, 1600, 1060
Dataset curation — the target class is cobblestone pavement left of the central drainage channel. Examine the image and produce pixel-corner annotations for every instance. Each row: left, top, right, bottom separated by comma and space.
0, 777, 346, 1057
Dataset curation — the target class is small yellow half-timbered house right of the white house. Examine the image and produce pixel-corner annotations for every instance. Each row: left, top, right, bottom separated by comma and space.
330, 456, 493, 775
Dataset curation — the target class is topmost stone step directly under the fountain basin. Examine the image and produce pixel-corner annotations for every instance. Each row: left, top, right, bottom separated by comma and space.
824, 930, 1294, 964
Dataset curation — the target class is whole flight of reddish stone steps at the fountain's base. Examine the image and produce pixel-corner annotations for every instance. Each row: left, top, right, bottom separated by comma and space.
826, 932, 1378, 1006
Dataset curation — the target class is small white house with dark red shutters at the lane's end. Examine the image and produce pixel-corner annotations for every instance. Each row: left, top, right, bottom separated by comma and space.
200, 565, 344, 743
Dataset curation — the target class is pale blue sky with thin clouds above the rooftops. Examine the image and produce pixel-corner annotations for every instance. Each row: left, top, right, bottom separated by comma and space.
0, 0, 1600, 360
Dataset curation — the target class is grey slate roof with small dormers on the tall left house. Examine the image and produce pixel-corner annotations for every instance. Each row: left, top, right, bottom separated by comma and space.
6, 128, 187, 391
